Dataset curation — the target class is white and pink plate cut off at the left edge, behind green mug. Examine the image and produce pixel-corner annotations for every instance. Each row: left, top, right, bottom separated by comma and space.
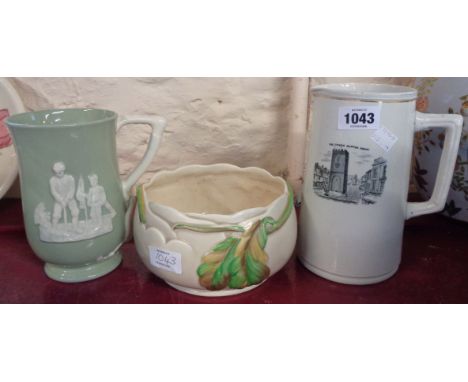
0, 78, 25, 199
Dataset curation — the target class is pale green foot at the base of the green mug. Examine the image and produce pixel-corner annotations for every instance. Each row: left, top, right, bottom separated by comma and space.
44, 251, 122, 283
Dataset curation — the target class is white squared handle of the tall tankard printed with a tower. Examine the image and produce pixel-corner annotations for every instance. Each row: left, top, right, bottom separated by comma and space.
406, 112, 463, 219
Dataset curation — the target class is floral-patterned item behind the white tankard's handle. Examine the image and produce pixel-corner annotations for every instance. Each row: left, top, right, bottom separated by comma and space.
413, 77, 468, 222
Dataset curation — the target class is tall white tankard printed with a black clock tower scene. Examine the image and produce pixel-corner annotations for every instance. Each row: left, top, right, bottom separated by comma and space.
299, 84, 463, 284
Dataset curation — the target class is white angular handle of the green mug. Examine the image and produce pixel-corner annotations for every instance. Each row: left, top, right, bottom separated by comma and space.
117, 115, 167, 198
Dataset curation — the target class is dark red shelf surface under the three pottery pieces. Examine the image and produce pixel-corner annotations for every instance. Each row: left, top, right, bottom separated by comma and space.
0, 199, 468, 303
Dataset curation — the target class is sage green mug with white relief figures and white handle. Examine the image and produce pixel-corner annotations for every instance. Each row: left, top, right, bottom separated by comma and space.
7, 109, 164, 282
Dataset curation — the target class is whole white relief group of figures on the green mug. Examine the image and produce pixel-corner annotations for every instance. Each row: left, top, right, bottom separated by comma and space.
34, 162, 117, 243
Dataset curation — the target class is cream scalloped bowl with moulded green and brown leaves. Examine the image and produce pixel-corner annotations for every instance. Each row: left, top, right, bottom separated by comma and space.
133, 164, 297, 296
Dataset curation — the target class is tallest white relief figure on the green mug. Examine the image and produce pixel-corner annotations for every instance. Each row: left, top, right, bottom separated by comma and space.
49, 162, 80, 227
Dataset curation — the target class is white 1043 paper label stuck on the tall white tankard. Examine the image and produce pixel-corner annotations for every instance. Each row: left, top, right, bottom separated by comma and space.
338, 105, 380, 130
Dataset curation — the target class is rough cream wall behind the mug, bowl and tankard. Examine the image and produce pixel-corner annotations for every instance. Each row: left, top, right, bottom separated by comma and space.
4, 77, 412, 197
